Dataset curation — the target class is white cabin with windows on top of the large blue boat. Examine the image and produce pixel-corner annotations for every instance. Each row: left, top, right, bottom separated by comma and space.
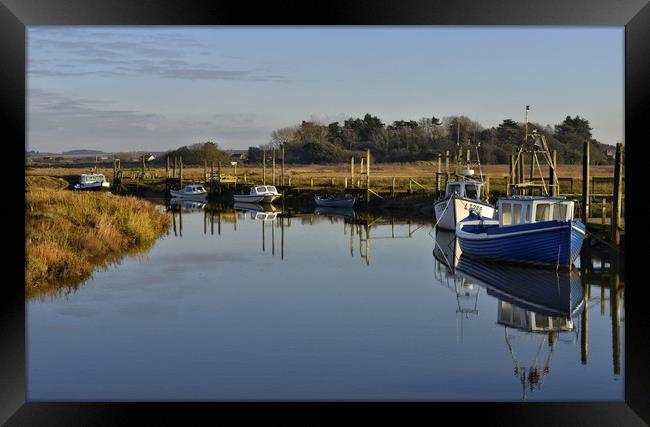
498, 196, 574, 226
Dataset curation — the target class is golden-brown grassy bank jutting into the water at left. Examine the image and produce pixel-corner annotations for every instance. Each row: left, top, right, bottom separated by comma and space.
25, 185, 169, 297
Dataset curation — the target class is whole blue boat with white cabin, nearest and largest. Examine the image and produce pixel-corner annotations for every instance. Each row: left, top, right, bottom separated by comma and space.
456, 196, 585, 269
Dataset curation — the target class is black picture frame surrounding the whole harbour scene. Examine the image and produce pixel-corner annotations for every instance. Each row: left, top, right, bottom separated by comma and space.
0, 0, 650, 426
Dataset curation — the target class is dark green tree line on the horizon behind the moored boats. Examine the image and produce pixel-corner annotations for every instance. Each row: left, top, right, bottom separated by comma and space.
248, 114, 613, 164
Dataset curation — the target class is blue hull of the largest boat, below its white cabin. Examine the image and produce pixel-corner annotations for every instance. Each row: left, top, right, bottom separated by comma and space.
456, 220, 585, 268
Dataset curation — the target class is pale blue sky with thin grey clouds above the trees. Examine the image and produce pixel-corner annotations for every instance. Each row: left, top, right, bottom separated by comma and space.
26, 26, 624, 152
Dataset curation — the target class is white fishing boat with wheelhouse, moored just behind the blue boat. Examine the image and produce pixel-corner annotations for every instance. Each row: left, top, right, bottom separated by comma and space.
433, 180, 495, 231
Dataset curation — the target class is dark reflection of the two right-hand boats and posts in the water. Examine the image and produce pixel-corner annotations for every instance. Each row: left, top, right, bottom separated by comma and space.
433, 230, 623, 400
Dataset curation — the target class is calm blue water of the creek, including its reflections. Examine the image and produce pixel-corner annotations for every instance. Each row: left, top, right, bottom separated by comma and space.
27, 201, 625, 401
